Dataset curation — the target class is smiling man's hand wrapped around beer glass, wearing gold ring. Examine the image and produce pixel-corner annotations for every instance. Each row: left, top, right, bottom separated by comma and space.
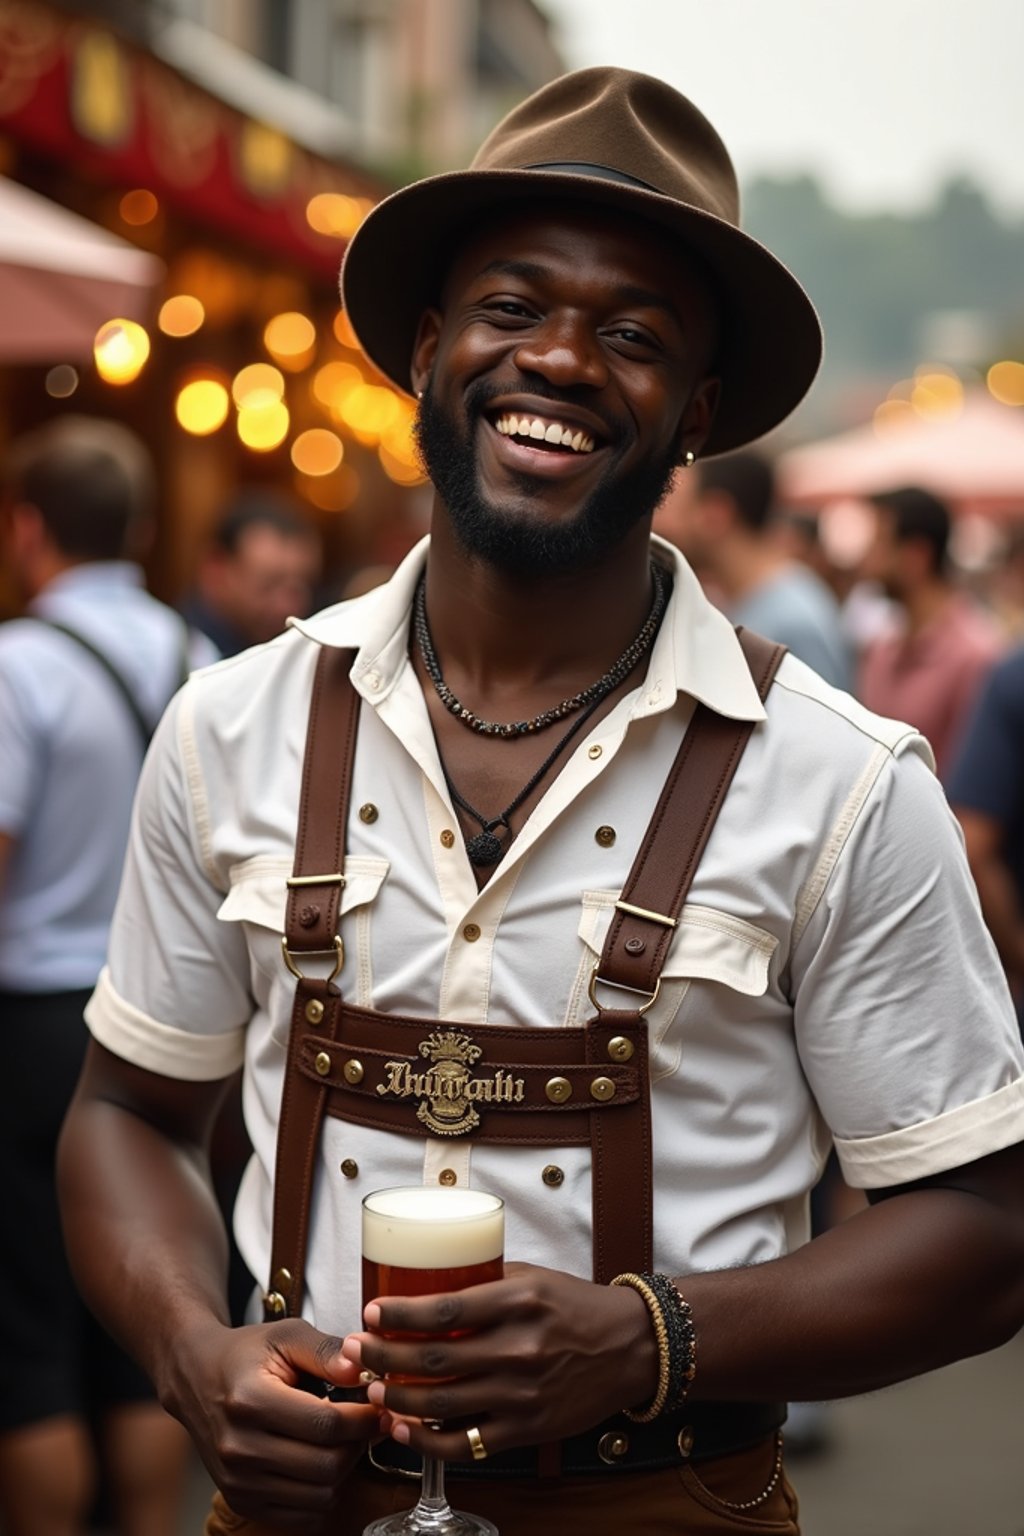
342, 1264, 657, 1461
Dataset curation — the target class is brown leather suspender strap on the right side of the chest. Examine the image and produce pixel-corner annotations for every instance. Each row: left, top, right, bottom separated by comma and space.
586, 630, 786, 1284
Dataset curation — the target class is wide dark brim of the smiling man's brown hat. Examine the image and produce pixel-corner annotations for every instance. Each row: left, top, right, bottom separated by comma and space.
341, 170, 821, 458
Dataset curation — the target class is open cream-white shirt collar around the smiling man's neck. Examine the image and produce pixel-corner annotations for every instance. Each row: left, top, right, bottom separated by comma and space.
289, 536, 765, 720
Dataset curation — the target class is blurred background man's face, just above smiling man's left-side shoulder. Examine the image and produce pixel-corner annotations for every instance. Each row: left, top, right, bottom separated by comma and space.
207, 524, 319, 645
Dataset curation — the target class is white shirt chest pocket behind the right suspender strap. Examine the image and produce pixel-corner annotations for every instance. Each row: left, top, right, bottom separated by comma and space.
567, 891, 778, 1083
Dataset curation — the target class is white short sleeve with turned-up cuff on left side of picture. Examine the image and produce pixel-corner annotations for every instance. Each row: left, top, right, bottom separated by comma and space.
86, 684, 253, 1080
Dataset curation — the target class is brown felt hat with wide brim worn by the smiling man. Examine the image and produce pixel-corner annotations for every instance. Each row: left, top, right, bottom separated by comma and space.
341, 68, 821, 455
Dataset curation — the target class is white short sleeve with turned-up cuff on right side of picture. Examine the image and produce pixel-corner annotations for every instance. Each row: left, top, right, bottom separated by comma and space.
794, 751, 1024, 1189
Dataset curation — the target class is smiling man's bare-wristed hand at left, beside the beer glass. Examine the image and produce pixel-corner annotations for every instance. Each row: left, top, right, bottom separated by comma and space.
166, 1319, 382, 1533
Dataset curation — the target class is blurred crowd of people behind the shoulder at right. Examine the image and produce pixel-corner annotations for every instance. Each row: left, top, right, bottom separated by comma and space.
654, 450, 1024, 1038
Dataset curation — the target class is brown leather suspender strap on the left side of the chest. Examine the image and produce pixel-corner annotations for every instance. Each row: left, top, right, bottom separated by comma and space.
263, 647, 359, 1319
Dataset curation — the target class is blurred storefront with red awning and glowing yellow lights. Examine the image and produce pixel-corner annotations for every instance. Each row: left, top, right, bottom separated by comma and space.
0, 0, 557, 607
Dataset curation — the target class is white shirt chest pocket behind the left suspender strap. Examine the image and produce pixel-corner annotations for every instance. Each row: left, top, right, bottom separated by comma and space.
216, 854, 391, 1040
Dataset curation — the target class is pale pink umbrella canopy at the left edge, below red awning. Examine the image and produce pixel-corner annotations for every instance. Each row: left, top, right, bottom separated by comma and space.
0, 177, 164, 362
